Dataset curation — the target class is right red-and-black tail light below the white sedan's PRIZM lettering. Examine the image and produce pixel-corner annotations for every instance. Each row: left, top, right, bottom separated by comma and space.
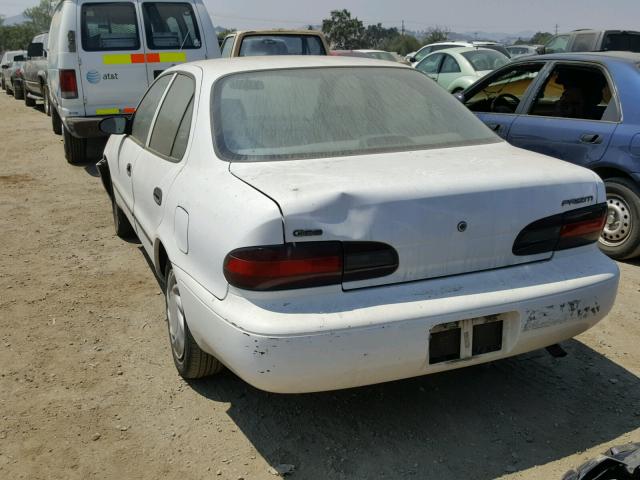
513, 203, 607, 255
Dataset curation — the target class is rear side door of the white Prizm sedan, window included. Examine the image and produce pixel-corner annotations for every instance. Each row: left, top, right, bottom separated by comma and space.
133, 73, 195, 254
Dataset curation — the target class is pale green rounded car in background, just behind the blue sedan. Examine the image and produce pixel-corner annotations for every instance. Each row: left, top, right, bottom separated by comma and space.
415, 47, 509, 93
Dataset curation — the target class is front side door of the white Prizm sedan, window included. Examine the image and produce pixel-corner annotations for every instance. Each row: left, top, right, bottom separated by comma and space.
111, 76, 171, 225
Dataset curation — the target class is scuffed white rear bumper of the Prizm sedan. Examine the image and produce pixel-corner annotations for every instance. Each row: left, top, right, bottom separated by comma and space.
175, 246, 619, 393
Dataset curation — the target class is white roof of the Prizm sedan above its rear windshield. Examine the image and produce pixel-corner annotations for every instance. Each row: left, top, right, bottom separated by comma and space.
178, 55, 413, 79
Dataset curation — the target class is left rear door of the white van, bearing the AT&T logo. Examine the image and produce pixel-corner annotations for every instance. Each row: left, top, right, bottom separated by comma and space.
78, 1, 149, 116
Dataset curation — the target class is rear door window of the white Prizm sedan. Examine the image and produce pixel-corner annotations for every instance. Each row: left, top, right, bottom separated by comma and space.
149, 75, 195, 161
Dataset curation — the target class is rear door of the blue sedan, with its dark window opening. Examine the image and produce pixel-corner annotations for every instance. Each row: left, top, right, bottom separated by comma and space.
508, 63, 620, 166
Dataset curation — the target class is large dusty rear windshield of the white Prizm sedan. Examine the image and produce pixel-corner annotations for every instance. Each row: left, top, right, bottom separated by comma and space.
212, 67, 499, 161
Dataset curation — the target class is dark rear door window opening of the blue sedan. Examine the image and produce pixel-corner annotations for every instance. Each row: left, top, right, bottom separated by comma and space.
529, 65, 620, 122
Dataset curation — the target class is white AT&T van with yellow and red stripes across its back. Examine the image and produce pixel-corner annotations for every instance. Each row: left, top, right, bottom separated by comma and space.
45, 0, 220, 163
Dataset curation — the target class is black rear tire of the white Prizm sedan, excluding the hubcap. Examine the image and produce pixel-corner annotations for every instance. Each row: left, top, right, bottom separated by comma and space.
164, 262, 223, 379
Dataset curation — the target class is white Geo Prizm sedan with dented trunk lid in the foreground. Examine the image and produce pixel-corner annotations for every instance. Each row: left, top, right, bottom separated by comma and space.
99, 57, 619, 392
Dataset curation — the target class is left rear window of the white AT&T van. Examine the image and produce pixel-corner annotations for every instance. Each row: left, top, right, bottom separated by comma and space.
81, 2, 140, 52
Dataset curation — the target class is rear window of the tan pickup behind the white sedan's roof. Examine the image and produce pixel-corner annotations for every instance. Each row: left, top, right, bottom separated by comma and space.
240, 35, 327, 57
